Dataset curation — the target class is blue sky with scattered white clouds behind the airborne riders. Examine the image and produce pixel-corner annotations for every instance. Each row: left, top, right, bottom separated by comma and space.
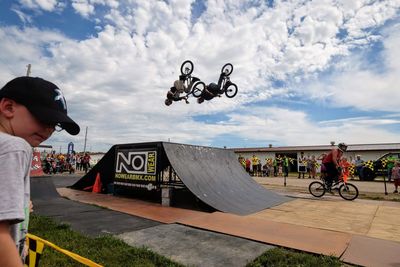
0, 0, 400, 152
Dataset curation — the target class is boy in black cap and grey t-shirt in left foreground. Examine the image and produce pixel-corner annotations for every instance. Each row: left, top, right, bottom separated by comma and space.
0, 77, 80, 266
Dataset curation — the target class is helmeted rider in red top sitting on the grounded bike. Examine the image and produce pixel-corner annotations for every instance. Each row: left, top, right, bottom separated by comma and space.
322, 143, 347, 189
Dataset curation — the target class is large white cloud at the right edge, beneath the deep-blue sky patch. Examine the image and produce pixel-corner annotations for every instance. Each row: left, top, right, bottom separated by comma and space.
309, 21, 400, 112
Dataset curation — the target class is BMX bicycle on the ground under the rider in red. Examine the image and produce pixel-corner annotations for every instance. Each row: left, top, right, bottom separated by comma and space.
308, 177, 358, 200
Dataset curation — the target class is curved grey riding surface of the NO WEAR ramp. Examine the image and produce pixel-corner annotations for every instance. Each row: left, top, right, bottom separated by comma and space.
163, 143, 290, 215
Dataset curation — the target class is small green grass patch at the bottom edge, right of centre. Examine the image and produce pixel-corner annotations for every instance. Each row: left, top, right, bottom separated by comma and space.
246, 248, 343, 267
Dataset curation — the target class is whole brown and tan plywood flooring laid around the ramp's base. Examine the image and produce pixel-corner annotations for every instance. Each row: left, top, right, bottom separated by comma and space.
58, 188, 400, 266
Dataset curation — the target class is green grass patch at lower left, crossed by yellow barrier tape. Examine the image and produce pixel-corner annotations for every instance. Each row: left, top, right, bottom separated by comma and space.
29, 215, 183, 267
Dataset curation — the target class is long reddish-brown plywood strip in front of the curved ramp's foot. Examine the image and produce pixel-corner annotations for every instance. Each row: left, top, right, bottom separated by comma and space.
180, 212, 351, 257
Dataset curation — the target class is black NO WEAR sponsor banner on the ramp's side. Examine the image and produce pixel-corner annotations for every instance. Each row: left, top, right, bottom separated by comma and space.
114, 149, 157, 190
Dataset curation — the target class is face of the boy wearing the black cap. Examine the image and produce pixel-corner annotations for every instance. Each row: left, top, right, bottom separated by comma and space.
10, 102, 54, 147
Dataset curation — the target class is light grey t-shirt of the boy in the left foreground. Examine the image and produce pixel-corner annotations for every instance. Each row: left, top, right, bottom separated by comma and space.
0, 132, 32, 259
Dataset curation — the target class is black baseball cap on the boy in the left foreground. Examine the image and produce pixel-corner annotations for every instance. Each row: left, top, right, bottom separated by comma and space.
0, 76, 80, 135
